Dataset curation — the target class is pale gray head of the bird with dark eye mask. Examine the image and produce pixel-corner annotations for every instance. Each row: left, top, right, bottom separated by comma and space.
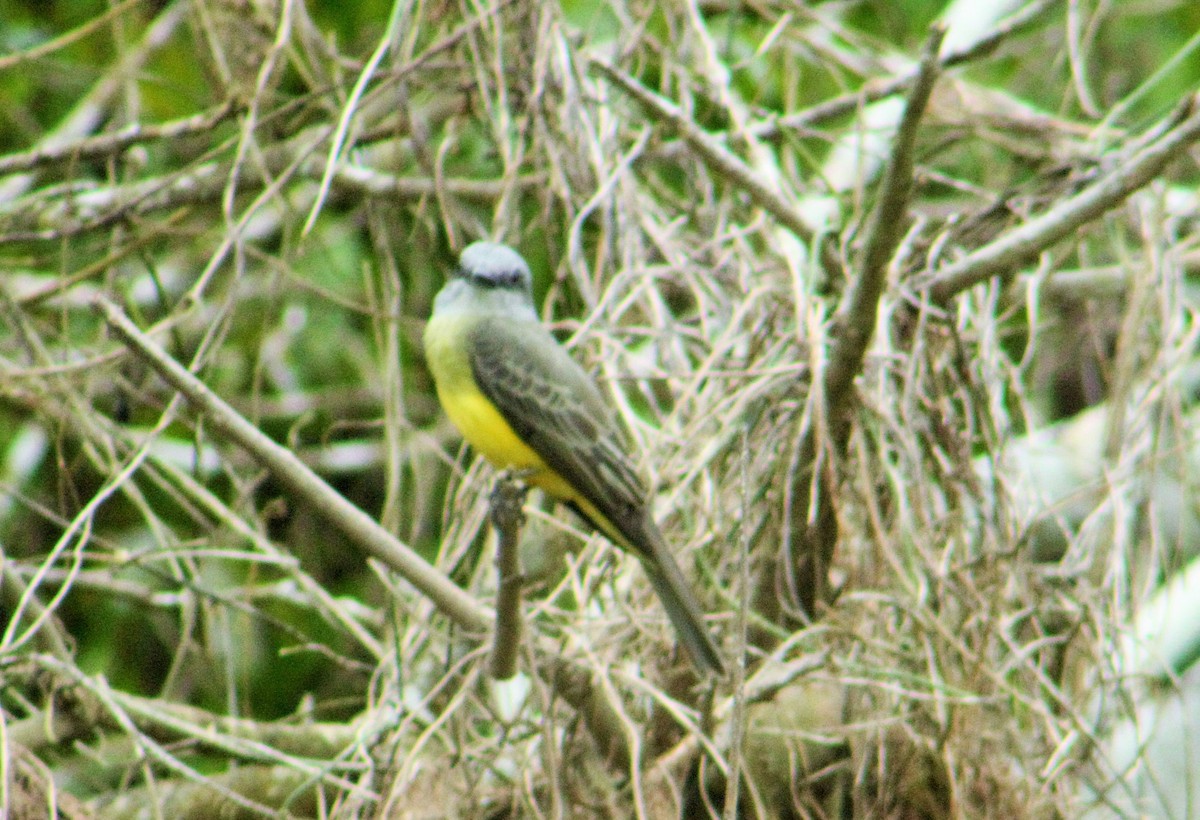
433, 243, 538, 321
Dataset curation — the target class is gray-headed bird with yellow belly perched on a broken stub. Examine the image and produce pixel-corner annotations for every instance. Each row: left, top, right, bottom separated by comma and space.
425, 243, 724, 675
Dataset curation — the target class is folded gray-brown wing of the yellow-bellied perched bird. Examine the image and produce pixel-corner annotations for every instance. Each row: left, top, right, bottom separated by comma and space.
470, 318, 646, 549
